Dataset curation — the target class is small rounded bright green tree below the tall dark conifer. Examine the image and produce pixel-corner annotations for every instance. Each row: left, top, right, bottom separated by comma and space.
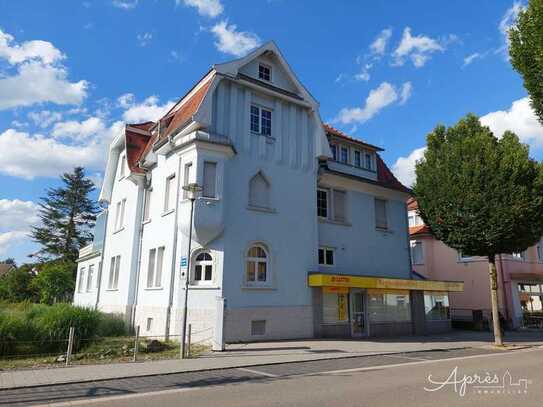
32, 261, 75, 304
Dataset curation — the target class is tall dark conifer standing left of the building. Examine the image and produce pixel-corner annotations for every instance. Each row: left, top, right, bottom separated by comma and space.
31, 167, 98, 262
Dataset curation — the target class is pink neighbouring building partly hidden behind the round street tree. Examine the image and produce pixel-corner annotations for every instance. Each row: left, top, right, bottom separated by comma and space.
408, 198, 543, 328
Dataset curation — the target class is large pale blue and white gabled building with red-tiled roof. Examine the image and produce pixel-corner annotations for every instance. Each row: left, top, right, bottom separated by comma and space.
74, 42, 462, 349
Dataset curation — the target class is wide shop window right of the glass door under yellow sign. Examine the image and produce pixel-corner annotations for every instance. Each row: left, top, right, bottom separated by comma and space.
368, 290, 411, 322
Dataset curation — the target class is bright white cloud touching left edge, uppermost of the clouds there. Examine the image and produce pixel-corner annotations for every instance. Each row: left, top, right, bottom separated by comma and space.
0, 29, 65, 65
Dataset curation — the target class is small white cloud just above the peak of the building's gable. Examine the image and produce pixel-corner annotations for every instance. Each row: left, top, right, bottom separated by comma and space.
211, 20, 260, 57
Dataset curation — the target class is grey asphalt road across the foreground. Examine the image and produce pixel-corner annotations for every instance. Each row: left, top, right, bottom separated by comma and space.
0, 348, 543, 407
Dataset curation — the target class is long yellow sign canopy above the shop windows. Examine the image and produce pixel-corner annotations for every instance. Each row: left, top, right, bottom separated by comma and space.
308, 273, 464, 292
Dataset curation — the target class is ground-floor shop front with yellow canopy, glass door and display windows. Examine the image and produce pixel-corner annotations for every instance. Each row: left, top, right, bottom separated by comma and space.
308, 273, 463, 338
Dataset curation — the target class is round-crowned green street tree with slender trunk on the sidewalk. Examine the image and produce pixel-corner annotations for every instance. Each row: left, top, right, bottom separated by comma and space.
413, 114, 543, 345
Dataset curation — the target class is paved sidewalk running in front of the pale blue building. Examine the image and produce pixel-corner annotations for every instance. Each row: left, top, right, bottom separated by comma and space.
0, 331, 543, 390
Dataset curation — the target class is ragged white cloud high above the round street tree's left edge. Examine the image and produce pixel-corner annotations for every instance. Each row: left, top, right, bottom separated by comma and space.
392, 27, 445, 68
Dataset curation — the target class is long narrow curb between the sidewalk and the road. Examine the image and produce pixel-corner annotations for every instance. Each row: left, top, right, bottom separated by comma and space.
0, 346, 478, 394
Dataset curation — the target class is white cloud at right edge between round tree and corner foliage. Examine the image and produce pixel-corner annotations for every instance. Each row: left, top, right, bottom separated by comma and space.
481, 97, 543, 147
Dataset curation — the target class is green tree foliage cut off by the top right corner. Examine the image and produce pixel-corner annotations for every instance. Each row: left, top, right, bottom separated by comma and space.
509, 0, 543, 124
